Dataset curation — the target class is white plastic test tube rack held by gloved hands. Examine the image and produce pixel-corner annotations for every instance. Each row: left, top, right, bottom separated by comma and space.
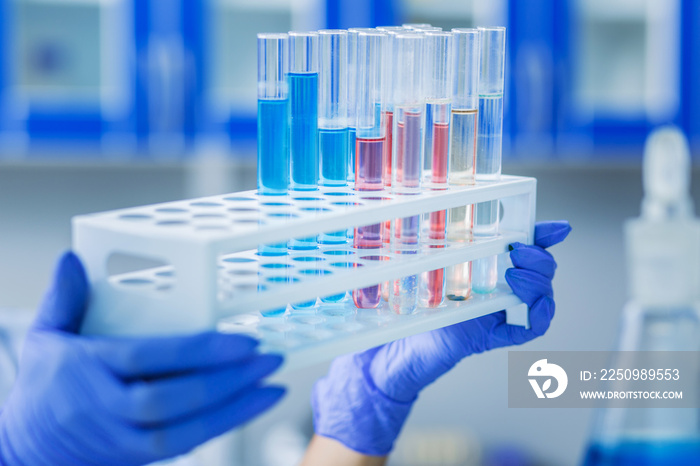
73, 175, 537, 369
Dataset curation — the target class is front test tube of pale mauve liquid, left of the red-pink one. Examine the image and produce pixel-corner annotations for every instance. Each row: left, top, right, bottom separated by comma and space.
389, 32, 425, 314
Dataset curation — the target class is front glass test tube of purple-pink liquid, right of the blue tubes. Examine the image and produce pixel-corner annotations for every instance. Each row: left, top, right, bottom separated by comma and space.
352, 31, 387, 309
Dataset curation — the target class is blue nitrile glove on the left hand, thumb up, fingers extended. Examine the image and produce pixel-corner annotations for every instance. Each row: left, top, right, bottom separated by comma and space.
0, 253, 284, 466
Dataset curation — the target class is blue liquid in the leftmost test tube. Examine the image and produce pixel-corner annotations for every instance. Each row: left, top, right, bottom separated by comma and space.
258, 99, 289, 194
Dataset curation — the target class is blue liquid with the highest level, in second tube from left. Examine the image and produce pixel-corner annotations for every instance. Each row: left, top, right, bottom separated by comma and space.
288, 73, 319, 190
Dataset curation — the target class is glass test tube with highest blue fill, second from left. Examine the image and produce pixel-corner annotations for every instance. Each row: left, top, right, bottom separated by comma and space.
287, 32, 320, 255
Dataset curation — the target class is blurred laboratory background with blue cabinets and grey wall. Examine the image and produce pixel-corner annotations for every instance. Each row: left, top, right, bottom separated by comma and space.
0, 0, 700, 466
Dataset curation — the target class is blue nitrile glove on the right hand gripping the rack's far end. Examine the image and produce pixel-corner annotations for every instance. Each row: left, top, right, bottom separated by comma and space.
311, 222, 571, 456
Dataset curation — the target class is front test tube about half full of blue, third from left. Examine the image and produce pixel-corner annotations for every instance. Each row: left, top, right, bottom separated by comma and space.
318, 29, 348, 303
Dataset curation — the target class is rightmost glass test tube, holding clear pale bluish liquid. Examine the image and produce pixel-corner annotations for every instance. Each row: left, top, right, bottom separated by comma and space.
472, 27, 506, 293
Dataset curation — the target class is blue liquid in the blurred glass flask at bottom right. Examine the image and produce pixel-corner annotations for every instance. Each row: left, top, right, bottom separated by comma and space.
583, 440, 700, 466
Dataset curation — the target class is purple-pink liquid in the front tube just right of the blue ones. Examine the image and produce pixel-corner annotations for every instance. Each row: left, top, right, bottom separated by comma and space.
352, 138, 384, 309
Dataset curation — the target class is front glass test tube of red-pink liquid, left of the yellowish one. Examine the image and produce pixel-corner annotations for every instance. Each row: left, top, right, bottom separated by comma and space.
418, 32, 453, 307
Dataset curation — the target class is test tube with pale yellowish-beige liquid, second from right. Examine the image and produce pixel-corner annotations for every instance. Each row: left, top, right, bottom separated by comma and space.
445, 28, 480, 301
